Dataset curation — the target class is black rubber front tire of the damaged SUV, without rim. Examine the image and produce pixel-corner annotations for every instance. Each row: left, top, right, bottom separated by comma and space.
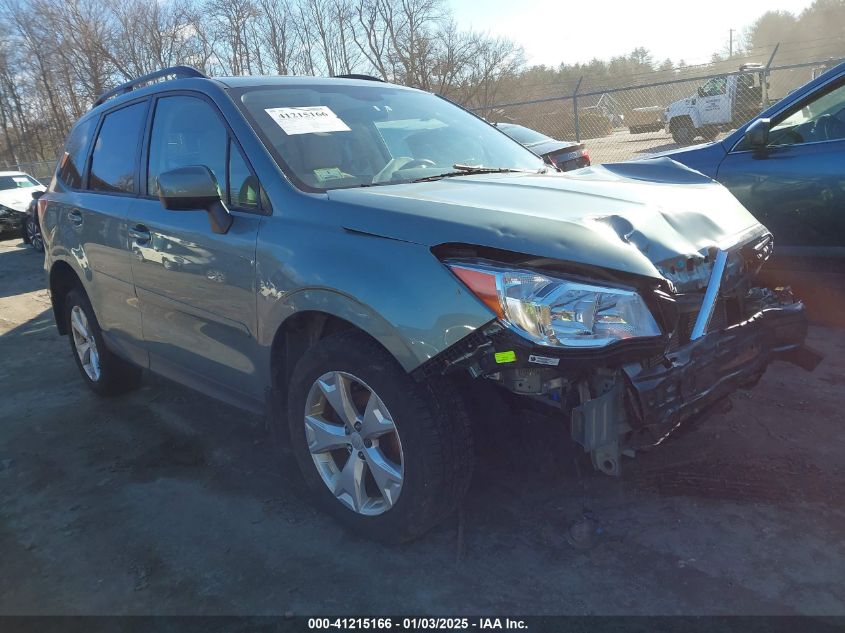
287, 331, 475, 543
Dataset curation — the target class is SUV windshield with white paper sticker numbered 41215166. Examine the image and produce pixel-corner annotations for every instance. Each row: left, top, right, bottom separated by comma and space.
238, 84, 545, 191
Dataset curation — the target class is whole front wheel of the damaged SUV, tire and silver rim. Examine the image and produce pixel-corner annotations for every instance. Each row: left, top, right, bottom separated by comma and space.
287, 332, 473, 542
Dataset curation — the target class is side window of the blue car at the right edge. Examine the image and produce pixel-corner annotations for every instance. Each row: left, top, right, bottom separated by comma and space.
769, 83, 845, 145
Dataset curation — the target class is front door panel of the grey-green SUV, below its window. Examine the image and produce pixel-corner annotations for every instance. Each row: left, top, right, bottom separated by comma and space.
129, 199, 264, 399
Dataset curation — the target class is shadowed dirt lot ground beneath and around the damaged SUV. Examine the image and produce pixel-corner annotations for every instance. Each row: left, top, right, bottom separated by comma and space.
0, 235, 845, 615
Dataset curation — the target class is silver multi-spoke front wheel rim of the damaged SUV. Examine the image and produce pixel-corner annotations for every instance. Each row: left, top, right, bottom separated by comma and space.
304, 371, 405, 516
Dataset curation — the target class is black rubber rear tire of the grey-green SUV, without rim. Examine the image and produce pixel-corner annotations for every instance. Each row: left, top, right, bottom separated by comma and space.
64, 288, 141, 396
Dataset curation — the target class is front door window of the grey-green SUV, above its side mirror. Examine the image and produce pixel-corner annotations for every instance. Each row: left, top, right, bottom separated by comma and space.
147, 96, 227, 199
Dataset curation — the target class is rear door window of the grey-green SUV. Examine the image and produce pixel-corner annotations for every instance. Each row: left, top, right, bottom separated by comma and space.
88, 102, 147, 193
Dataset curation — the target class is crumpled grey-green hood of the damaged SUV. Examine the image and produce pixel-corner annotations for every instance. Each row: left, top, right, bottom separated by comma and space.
328, 159, 766, 278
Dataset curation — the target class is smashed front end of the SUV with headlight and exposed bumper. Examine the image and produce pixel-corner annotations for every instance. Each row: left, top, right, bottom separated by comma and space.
416, 233, 821, 475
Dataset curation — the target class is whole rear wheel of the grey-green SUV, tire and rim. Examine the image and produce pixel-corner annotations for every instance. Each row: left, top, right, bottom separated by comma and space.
64, 288, 141, 396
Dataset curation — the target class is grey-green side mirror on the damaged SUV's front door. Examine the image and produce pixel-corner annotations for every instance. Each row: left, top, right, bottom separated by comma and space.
158, 165, 232, 233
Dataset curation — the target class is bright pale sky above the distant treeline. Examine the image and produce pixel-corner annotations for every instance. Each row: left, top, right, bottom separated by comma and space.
446, 0, 812, 66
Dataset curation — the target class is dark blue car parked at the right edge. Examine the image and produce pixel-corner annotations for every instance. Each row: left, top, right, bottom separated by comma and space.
661, 63, 845, 325
